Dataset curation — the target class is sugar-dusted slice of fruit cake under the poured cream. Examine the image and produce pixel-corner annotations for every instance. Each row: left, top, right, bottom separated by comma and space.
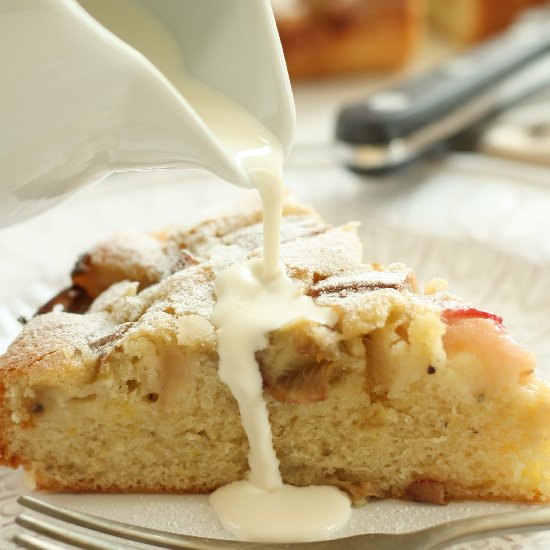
0, 198, 550, 503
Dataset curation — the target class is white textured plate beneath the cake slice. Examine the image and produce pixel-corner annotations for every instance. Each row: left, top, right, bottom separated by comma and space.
0, 153, 550, 550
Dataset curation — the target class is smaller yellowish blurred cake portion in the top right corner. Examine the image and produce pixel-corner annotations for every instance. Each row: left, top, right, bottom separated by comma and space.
436, 0, 550, 44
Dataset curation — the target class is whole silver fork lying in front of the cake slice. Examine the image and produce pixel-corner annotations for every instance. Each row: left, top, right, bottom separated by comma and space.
13, 496, 550, 550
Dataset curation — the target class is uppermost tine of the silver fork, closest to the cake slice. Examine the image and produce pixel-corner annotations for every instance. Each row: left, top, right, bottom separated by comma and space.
17, 496, 265, 550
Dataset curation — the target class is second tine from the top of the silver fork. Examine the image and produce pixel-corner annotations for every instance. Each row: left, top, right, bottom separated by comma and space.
14, 514, 135, 550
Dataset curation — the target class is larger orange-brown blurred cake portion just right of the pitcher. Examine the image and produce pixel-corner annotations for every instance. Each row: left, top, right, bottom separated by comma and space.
272, 0, 424, 79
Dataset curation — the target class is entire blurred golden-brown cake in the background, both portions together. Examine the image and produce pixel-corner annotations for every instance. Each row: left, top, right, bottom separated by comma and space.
271, 0, 550, 80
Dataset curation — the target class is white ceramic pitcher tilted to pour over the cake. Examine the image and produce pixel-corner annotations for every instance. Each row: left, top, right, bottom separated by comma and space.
0, 0, 295, 226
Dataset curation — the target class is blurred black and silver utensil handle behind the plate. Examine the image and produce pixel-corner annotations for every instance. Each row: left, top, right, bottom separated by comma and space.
336, 8, 550, 170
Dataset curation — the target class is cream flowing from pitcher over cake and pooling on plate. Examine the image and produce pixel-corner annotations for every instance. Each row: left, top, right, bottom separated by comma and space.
83, 0, 350, 542
